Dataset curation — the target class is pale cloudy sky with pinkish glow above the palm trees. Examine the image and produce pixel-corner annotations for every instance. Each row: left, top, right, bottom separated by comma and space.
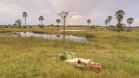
0, 0, 139, 26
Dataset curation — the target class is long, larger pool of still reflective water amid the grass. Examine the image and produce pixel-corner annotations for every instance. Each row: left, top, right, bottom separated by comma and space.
17, 32, 88, 42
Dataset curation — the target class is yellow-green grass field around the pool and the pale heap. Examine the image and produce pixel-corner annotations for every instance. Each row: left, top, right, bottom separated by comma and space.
0, 27, 139, 78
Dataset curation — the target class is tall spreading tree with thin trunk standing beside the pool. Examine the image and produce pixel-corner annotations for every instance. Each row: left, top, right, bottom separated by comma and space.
58, 11, 69, 40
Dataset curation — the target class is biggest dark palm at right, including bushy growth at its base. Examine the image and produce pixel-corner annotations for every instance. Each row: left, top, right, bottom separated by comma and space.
115, 10, 125, 31
